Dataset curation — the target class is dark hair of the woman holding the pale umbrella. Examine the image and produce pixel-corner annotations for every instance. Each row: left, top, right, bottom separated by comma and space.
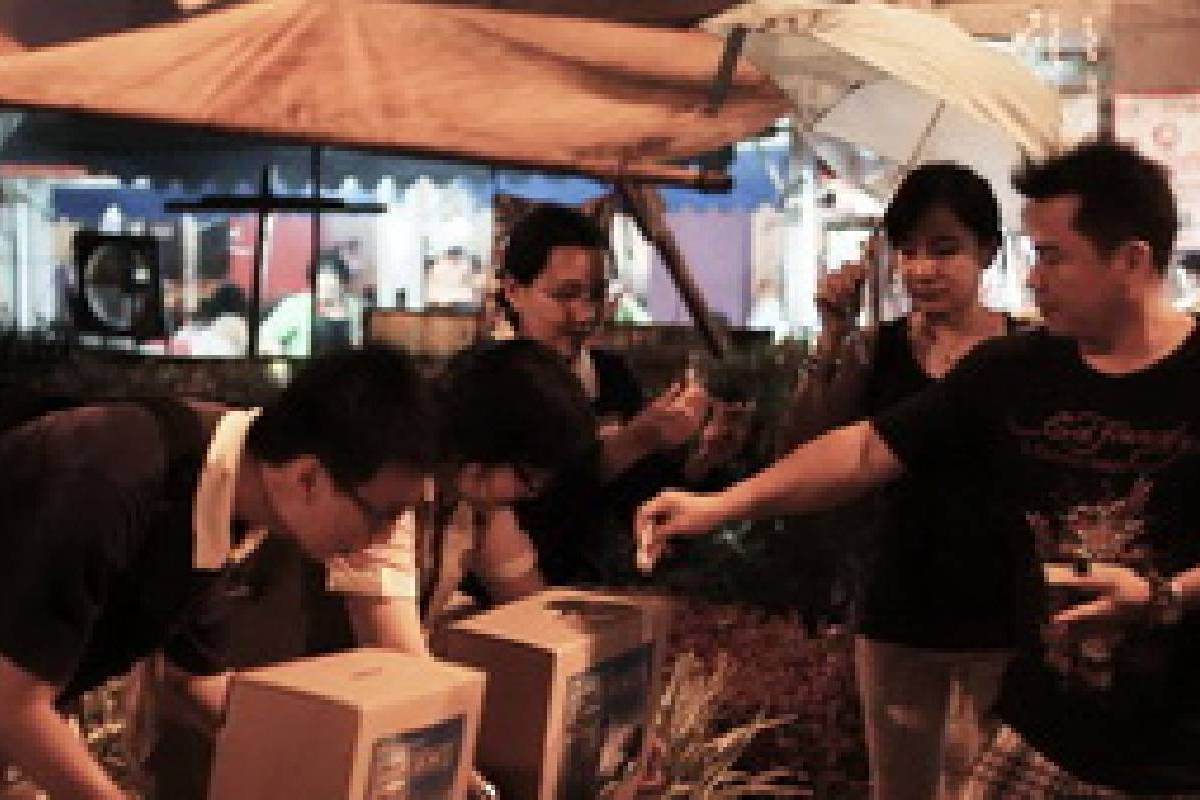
883, 162, 1000, 262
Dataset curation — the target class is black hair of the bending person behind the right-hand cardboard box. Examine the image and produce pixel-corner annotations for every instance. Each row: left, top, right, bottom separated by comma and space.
438, 339, 596, 473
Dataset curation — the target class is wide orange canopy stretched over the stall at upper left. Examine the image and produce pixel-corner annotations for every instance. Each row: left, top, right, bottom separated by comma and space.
0, 0, 786, 184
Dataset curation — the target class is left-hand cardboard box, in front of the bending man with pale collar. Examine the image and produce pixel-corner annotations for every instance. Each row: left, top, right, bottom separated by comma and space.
209, 649, 484, 800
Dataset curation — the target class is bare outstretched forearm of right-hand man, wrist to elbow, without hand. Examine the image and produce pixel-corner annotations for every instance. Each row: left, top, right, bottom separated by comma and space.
718, 422, 901, 519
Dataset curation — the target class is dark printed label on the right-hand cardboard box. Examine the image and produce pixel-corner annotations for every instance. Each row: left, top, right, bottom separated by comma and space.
557, 644, 654, 800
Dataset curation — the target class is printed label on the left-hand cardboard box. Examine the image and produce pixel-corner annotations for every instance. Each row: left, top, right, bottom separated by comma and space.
364, 715, 467, 800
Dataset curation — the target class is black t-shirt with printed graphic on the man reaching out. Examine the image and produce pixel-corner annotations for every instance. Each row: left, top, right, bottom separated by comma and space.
872, 321, 1200, 792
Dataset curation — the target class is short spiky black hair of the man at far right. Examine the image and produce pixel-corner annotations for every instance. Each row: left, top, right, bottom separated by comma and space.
1013, 139, 1180, 273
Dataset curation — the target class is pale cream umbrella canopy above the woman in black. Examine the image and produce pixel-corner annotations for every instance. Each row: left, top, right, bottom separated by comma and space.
704, 0, 1062, 217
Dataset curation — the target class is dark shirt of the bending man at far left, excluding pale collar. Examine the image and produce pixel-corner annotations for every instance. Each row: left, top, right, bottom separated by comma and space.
0, 401, 236, 699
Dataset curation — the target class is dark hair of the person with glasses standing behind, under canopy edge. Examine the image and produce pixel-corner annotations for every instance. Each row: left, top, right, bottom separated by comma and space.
504, 203, 608, 285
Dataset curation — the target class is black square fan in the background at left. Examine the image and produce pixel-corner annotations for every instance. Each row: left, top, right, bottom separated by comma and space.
73, 230, 166, 339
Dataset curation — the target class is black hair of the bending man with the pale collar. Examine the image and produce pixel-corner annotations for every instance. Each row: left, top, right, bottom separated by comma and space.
246, 345, 437, 487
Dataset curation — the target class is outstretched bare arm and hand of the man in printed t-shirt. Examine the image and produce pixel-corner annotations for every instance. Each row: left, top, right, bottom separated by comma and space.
636, 421, 904, 569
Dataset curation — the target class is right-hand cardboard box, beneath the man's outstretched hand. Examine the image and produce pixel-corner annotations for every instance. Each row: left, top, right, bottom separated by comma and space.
443, 589, 668, 800
